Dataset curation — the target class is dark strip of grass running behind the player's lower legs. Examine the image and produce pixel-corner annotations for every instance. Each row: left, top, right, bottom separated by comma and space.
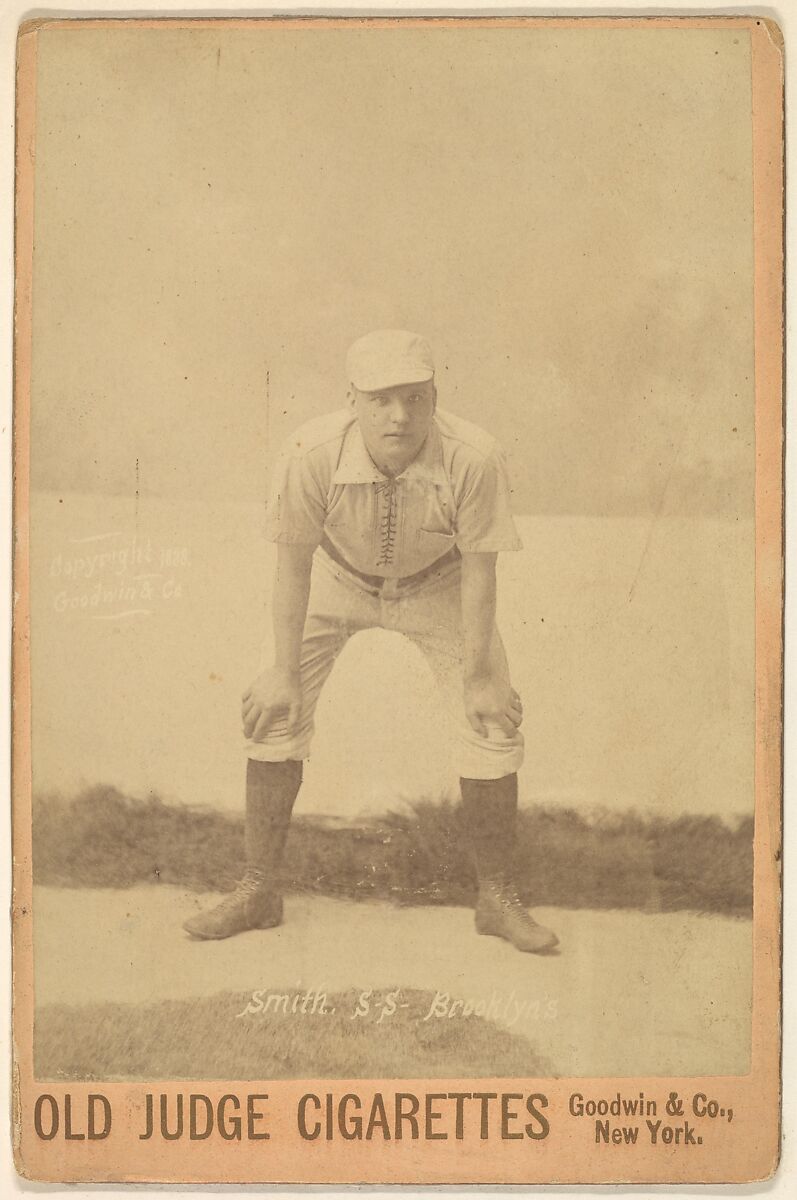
34, 786, 753, 917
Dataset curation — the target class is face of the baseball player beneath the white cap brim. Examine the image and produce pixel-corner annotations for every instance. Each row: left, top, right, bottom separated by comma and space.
352, 379, 437, 475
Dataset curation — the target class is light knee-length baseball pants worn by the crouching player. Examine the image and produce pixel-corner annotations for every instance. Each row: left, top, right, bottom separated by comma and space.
246, 548, 523, 779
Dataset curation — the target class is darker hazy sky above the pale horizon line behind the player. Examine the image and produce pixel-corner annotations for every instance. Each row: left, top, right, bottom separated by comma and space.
32, 23, 754, 516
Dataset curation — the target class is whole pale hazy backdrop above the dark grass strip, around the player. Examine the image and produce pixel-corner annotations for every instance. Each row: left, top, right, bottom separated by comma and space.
31, 25, 754, 815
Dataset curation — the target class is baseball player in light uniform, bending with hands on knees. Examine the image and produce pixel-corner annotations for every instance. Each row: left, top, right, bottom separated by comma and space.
184, 330, 557, 952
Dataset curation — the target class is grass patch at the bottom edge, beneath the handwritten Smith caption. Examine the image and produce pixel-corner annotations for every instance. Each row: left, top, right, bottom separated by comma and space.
35, 989, 551, 1081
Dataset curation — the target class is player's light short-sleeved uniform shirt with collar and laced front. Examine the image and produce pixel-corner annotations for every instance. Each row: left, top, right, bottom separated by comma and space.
265, 408, 522, 578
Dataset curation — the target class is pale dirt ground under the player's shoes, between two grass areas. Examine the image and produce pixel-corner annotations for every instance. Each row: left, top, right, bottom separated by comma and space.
34, 886, 751, 1076
